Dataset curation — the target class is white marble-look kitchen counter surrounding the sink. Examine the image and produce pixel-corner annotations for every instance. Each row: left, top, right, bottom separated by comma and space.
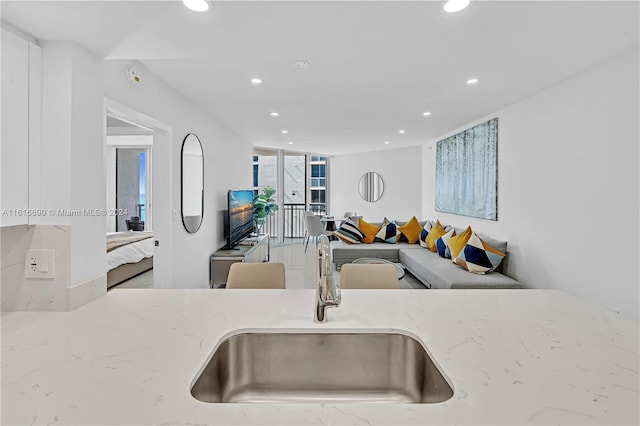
1, 289, 640, 425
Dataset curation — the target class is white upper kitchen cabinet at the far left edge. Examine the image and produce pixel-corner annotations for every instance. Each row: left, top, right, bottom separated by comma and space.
0, 29, 42, 226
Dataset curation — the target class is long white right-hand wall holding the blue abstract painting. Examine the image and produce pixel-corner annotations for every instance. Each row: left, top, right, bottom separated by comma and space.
423, 50, 640, 319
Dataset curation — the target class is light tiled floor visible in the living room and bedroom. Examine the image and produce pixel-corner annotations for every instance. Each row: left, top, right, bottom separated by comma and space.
114, 240, 424, 288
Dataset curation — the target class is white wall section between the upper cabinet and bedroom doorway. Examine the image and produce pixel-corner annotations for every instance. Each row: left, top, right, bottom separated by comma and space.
38, 41, 106, 300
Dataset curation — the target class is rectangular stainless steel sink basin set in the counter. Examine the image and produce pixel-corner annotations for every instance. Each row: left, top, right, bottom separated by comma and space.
191, 333, 453, 403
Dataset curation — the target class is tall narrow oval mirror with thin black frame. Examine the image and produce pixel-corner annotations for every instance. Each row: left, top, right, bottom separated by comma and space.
180, 133, 204, 234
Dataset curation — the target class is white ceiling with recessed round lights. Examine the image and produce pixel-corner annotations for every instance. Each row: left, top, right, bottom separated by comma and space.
1, 0, 639, 155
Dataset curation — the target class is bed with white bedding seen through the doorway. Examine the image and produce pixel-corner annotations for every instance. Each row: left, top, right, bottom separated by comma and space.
107, 231, 153, 288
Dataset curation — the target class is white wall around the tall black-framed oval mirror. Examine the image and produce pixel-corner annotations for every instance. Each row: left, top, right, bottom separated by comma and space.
104, 61, 252, 288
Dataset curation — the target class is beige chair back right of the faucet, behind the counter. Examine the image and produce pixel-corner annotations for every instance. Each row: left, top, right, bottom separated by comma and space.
340, 263, 400, 290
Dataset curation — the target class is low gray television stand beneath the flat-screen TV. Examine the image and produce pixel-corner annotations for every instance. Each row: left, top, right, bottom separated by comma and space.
209, 234, 269, 288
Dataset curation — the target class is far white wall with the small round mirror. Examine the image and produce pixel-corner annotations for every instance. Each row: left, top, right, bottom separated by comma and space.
329, 147, 422, 221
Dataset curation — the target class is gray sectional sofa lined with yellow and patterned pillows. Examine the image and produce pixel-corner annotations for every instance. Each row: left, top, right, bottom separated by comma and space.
331, 230, 522, 289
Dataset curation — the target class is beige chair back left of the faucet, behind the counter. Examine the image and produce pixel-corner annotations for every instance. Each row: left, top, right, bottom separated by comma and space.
226, 262, 286, 289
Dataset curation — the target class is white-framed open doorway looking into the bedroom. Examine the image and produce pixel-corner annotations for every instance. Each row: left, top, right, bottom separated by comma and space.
104, 98, 173, 288
